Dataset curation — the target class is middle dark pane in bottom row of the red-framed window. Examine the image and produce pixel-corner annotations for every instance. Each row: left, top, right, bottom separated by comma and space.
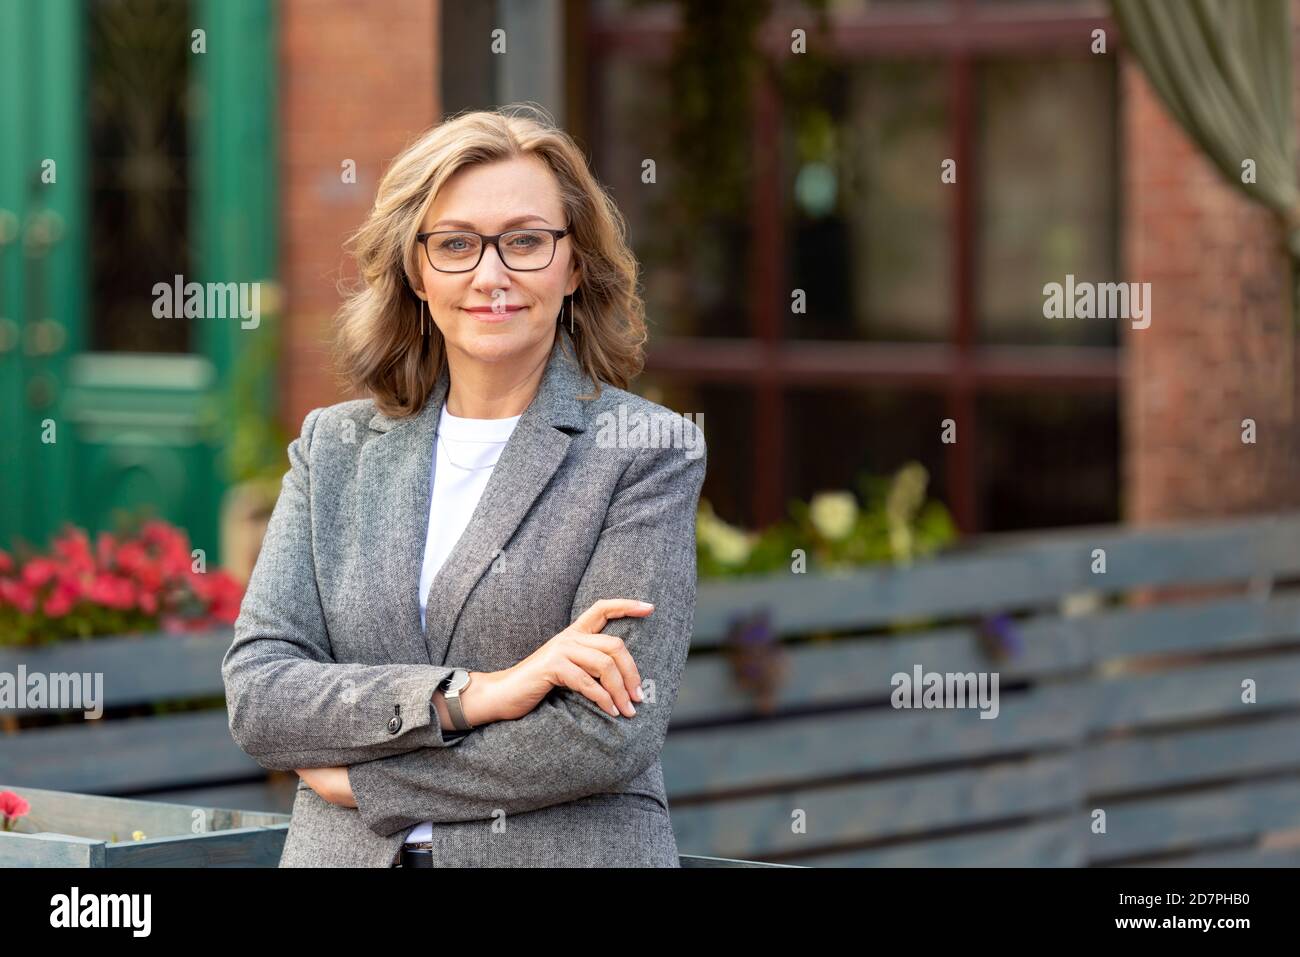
785, 389, 948, 520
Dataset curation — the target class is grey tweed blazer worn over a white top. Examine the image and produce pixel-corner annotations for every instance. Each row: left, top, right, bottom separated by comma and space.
221, 334, 707, 867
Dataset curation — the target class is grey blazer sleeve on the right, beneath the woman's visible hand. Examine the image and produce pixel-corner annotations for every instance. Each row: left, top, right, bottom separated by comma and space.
348, 420, 707, 836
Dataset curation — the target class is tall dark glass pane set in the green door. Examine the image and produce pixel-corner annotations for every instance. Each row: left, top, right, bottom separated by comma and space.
86, 0, 198, 352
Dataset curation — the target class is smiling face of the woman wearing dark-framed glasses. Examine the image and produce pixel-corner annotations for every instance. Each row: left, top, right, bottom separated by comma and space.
417, 156, 581, 363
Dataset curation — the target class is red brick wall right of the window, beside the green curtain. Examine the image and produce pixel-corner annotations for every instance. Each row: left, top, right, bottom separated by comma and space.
1121, 49, 1300, 524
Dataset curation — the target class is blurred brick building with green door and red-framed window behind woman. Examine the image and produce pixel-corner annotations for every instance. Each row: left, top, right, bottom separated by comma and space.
0, 0, 1300, 567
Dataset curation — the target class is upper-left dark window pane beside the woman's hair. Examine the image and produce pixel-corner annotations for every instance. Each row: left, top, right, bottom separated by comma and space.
594, 57, 750, 337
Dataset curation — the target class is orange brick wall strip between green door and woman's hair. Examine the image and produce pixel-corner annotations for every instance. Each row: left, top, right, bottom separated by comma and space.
280, 0, 441, 434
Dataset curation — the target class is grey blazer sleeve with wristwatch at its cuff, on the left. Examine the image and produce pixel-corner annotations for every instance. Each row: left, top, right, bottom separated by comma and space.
221, 408, 464, 771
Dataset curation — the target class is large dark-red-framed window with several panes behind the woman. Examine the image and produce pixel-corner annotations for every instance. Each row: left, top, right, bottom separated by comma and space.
579, 0, 1119, 532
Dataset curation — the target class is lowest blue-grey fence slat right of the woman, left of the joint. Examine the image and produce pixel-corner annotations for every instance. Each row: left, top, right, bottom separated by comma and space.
783, 820, 1084, 867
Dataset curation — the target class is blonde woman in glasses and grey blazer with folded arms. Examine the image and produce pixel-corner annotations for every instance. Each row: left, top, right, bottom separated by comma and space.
222, 109, 706, 867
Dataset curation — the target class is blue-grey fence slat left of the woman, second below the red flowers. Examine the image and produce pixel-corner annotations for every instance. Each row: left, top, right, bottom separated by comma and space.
0, 710, 258, 794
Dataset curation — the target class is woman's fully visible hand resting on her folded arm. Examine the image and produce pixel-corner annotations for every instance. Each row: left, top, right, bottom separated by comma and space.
464, 598, 654, 726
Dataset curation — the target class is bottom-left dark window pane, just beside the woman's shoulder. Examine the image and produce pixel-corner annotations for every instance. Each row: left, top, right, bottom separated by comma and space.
633, 372, 754, 528
